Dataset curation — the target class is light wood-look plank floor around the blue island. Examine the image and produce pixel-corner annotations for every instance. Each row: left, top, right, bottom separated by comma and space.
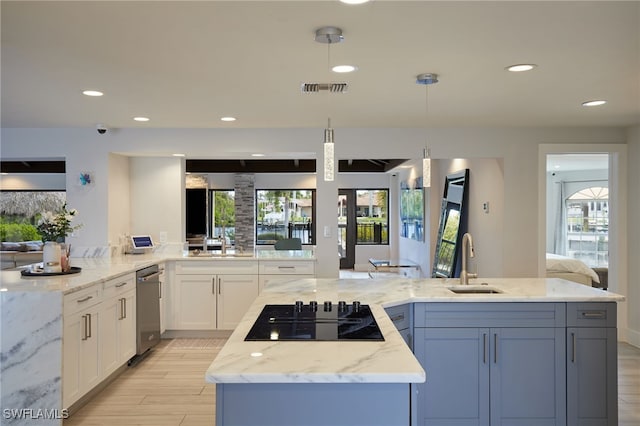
63, 339, 640, 426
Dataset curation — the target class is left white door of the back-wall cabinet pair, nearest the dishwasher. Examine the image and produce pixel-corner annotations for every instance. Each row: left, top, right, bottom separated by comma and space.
173, 274, 217, 330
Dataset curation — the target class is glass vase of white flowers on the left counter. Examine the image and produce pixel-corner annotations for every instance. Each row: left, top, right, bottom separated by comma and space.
36, 203, 82, 273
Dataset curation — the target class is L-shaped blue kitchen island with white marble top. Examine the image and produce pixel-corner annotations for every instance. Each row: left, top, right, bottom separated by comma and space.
205, 278, 624, 426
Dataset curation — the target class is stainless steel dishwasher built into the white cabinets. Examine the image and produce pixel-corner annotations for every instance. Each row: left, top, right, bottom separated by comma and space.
136, 265, 161, 357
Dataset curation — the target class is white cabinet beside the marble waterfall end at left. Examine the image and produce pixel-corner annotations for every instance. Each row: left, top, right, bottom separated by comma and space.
62, 285, 102, 408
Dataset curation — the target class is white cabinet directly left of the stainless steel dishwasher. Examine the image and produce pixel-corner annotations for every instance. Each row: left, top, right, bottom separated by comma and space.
100, 274, 136, 377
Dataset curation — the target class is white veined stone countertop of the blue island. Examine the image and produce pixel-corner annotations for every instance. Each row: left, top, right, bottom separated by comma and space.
205, 278, 624, 383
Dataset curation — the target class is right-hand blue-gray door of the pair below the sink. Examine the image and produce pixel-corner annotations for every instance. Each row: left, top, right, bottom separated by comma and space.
490, 328, 566, 426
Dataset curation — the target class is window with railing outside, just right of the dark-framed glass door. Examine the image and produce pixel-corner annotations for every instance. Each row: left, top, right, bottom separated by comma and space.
356, 189, 389, 244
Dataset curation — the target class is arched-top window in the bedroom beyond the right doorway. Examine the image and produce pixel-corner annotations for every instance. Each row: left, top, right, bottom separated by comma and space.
566, 187, 609, 268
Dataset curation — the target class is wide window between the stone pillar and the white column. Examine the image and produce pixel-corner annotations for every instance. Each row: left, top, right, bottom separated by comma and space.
256, 189, 315, 245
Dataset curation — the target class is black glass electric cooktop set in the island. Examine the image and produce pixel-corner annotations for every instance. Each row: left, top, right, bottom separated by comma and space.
244, 301, 384, 341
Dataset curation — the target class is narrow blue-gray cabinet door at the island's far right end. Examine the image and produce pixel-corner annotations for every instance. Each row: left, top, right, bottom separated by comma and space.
567, 327, 618, 426
